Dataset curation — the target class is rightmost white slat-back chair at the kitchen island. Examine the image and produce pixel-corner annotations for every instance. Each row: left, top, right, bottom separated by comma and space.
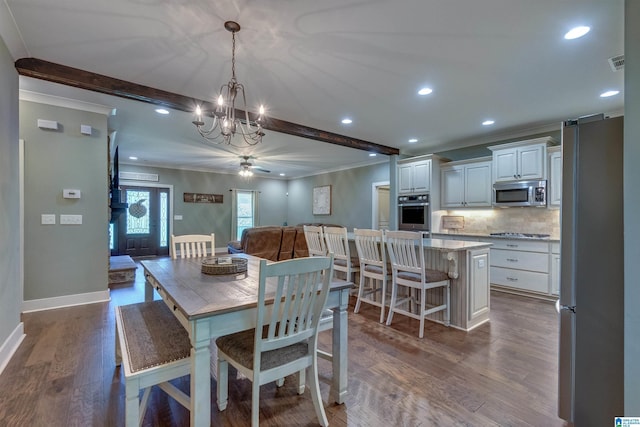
384, 231, 450, 338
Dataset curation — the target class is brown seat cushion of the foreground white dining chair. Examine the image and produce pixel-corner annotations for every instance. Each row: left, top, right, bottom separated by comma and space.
216, 327, 309, 371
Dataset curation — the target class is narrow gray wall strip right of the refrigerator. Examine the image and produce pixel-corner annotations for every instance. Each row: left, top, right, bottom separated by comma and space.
624, 0, 640, 417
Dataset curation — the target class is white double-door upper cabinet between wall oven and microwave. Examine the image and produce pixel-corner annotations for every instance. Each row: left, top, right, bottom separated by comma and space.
440, 159, 492, 209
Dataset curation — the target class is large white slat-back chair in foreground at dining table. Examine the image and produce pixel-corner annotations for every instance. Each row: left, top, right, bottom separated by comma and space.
216, 256, 333, 427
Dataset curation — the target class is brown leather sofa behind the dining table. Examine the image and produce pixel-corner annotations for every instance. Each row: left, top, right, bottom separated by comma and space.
227, 223, 338, 261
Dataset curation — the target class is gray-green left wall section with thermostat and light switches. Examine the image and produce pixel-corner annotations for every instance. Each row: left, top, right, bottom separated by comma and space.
20, 101, 109, 300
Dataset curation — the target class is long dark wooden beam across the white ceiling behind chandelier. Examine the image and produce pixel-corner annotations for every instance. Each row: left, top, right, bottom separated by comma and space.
15, 58, 400, 155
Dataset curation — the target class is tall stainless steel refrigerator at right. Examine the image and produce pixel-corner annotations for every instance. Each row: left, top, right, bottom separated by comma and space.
558, 114, 624, 427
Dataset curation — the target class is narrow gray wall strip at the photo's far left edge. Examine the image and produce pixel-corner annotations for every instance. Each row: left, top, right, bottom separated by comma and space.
0, 33, 22, 354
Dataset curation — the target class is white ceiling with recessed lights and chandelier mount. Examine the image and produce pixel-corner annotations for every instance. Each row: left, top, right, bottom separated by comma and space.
0, 0, 624, 177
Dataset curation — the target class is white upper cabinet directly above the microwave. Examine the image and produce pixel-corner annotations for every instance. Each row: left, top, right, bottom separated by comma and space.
489, 137, 555, 182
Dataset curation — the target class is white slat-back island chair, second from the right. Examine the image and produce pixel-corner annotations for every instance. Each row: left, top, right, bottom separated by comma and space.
353, 228, 391, 323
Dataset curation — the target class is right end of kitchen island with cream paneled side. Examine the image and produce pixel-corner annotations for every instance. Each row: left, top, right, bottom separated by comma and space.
424, 239, 491, 331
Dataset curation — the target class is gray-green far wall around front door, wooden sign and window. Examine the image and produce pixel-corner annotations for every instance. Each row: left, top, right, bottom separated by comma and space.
120, 162, 287, 248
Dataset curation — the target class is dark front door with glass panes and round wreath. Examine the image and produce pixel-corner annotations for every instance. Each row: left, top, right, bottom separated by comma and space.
116, 186, 169, 257
